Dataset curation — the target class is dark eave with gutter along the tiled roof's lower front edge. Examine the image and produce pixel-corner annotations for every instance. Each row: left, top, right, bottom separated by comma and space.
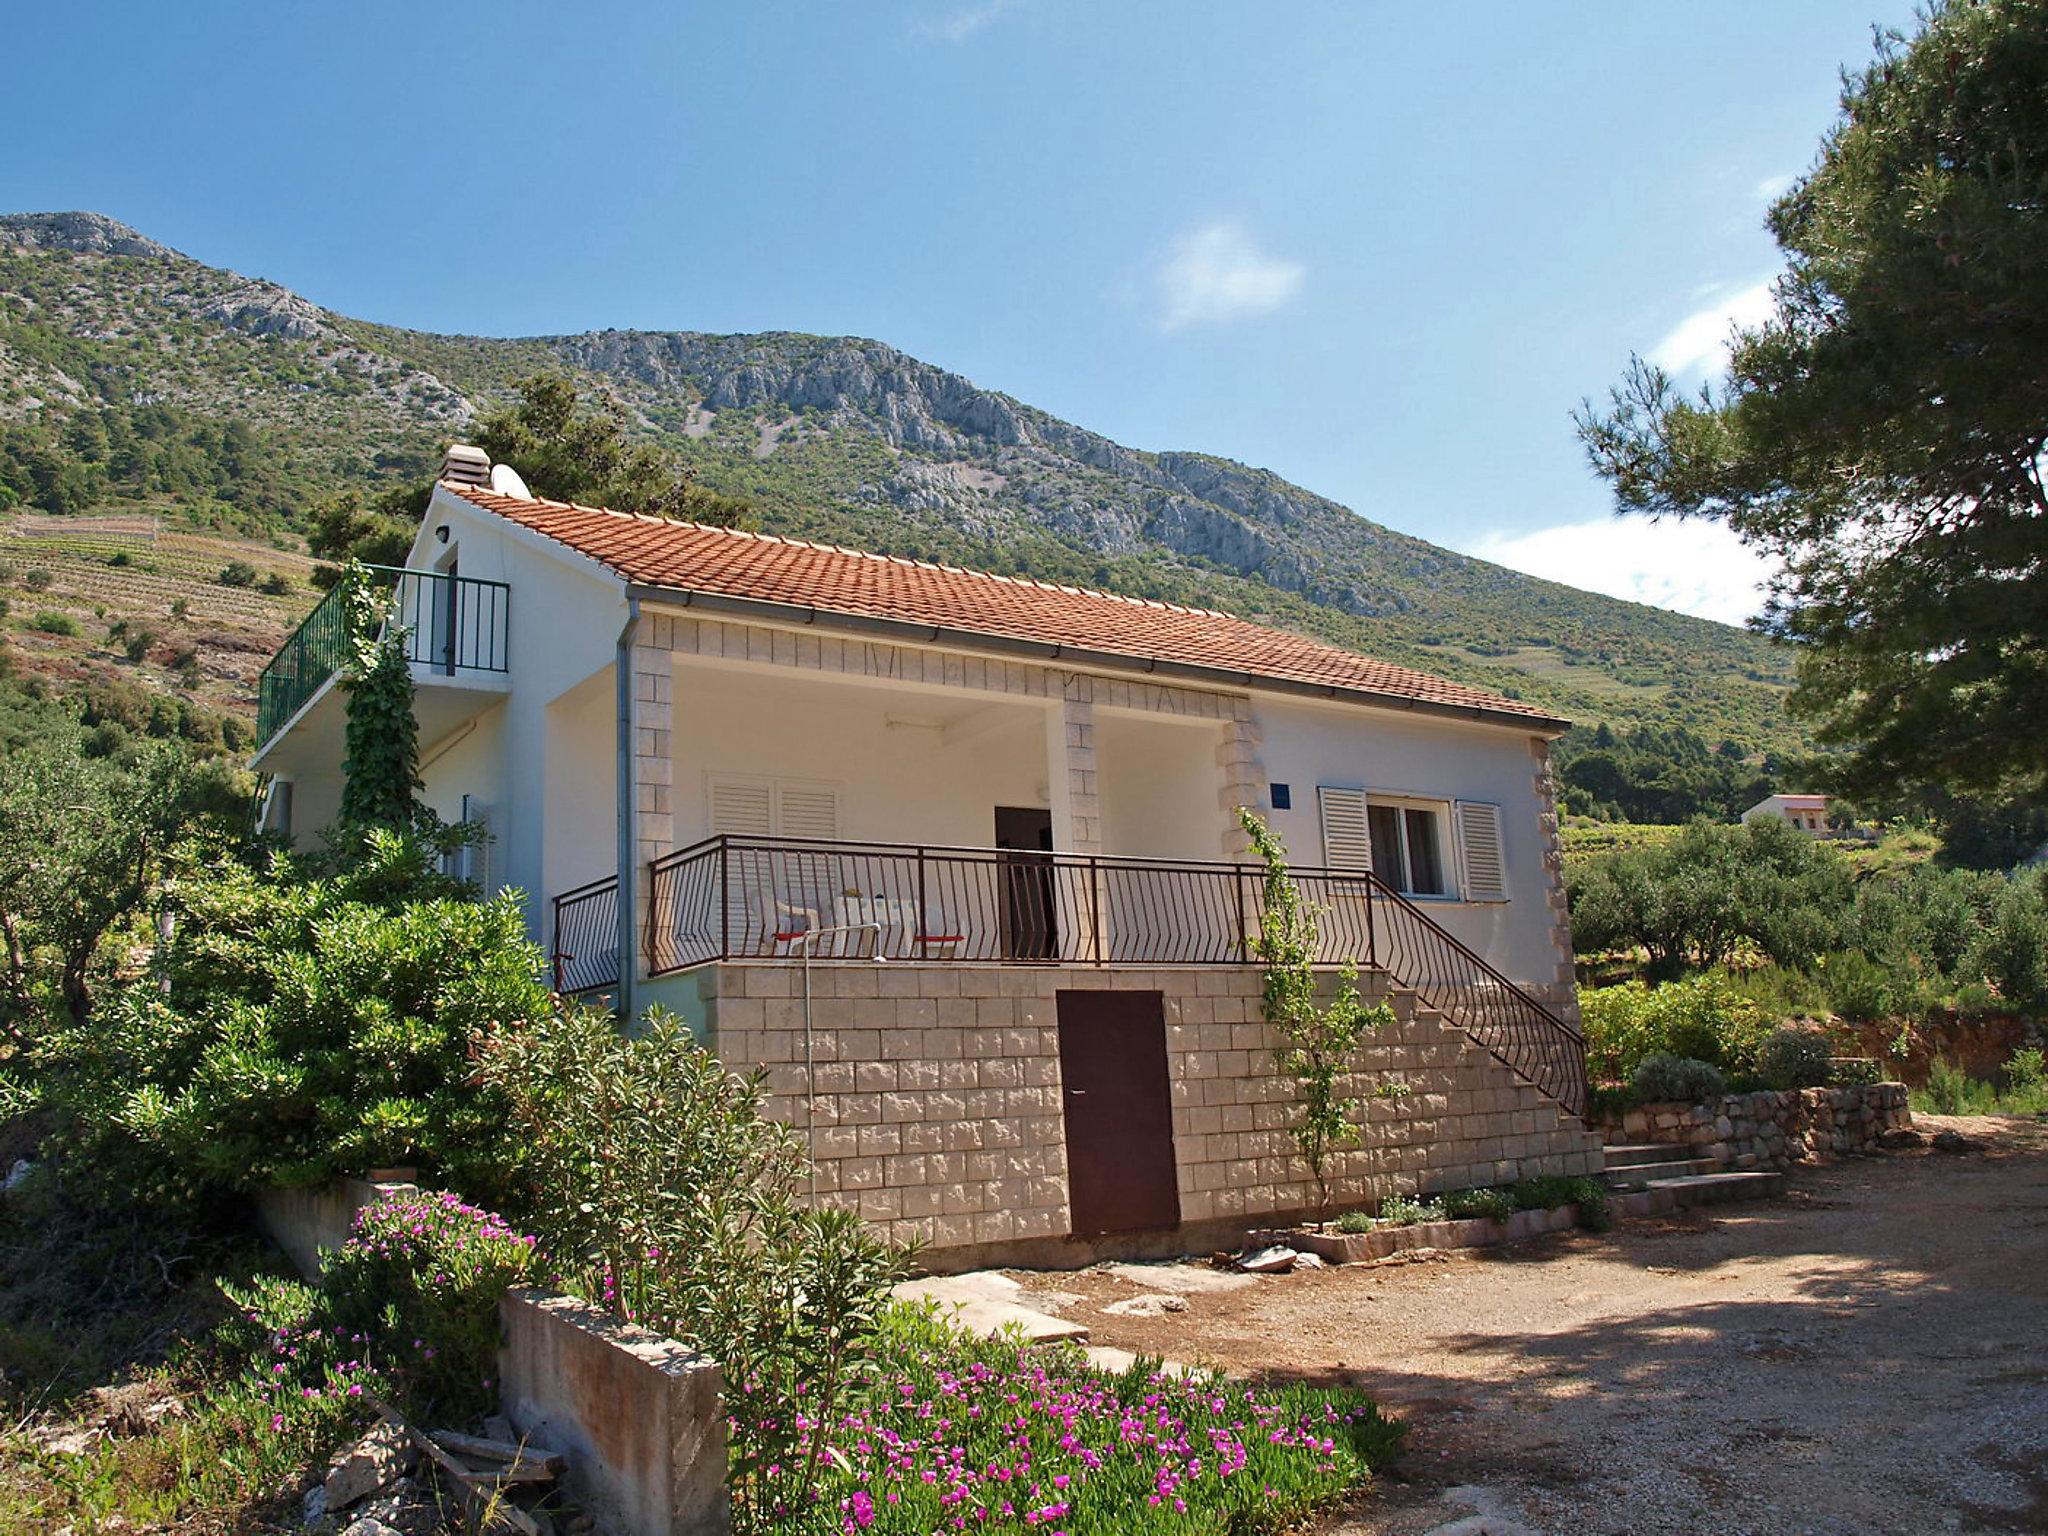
627, 582, 1571, 737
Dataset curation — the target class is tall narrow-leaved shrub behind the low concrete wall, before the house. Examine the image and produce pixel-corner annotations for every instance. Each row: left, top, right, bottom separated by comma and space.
481, 1008, 909, 1528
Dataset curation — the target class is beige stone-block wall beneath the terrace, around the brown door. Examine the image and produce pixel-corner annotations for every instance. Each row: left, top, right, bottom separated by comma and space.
694, 961, 1602, 1264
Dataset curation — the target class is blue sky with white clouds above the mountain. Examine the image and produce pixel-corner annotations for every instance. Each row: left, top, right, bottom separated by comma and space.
0, 0, 1911, 618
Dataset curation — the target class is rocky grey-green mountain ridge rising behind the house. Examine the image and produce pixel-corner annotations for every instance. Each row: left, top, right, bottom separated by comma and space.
0, 213, 1798, 750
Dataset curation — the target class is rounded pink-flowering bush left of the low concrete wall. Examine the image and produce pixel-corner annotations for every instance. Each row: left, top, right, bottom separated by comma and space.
319, 1192, 535, 1423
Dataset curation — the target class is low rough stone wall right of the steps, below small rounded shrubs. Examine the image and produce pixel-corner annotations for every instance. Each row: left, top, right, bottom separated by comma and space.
1599, 1083, 1913, 1169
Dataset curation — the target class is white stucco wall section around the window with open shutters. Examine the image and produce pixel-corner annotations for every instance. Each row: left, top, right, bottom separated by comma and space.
1253, 694, 1556, 981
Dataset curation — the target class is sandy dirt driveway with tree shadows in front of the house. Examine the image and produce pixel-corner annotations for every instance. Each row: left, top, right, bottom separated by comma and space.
1011, 1116, 2048, 1536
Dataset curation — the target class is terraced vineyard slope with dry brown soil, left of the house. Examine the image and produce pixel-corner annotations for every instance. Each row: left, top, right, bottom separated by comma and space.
0, 508, 319, 721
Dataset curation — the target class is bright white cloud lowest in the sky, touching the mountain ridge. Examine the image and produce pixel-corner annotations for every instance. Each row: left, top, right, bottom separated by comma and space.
1470, 518, 1776, 625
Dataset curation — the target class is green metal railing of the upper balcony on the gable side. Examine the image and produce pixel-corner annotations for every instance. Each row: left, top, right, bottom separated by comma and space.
256, 565, 512, 741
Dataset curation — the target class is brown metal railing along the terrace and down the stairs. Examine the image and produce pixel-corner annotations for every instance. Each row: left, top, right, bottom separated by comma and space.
598, 836, 1585, 1114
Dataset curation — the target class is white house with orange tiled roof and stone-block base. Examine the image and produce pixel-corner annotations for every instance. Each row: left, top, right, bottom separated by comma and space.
254, 449, 1597, 1262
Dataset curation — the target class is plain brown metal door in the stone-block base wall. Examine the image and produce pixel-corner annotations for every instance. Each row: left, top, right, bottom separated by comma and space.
1059, 991, 1180, 1235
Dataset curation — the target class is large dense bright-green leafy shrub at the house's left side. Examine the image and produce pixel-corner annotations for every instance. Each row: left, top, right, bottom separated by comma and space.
51, 834, 551, 1204
